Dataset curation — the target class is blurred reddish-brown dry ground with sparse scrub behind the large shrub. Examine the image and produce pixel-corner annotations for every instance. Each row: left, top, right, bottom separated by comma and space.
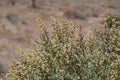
0, 0, 120, 75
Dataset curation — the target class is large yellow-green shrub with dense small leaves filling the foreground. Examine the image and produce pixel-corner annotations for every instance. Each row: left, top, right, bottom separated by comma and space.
7, 16, 120, 80
